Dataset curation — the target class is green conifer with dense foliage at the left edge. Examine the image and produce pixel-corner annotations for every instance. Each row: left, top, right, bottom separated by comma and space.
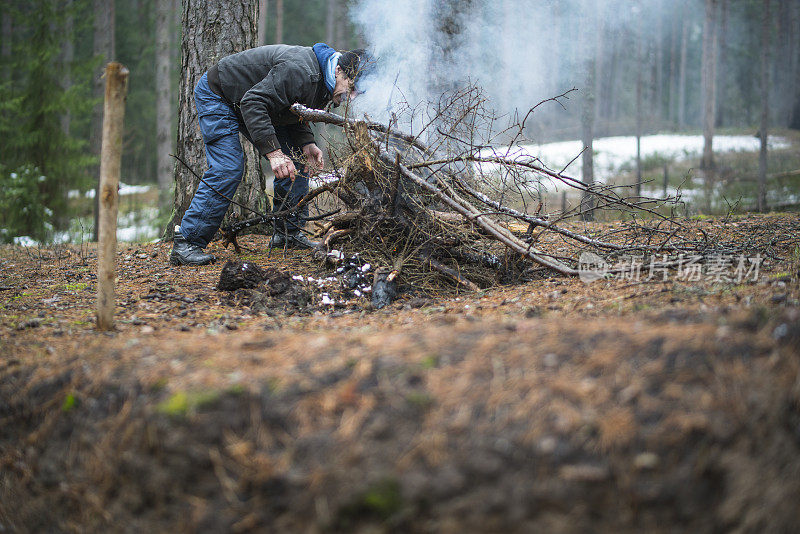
0, 0, 92, 240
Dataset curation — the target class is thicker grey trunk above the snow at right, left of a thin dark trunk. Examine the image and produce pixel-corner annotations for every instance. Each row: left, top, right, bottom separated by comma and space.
700, 0, 718, 171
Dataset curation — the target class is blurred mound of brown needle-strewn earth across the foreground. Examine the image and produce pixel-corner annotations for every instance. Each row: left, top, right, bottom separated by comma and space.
0, 308, 800, 532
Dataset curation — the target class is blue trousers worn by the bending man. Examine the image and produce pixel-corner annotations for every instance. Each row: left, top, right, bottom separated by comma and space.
181, 74, 308, 247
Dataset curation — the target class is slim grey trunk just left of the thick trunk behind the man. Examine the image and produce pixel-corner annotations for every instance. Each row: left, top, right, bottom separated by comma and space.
155, 0, 173, 208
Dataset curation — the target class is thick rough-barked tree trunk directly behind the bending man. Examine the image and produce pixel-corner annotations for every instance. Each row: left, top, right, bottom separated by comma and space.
170, 0, 264, 237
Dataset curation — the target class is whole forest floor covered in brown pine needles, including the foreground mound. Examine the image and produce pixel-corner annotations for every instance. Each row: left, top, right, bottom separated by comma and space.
0, 214, 800, 532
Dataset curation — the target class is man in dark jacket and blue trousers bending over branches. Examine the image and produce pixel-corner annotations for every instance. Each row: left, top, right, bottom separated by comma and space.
170, 43, 365, 265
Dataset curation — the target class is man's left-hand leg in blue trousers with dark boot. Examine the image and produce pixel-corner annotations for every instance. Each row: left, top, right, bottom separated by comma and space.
170, 74, 244, 264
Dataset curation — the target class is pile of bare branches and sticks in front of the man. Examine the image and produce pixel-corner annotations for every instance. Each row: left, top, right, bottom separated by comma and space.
225, 88, 764, 298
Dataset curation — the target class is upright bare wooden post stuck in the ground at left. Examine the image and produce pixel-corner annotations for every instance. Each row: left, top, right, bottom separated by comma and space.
97, 63, 128, 330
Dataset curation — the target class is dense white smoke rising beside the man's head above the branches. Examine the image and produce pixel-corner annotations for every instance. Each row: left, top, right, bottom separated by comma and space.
350, 0, 568, 129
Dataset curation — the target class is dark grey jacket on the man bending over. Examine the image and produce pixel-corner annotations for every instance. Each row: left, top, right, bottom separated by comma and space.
208, 45, 331, 155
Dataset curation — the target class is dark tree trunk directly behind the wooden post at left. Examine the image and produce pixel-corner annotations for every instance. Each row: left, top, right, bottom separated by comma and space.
89, 0, 115, 241
